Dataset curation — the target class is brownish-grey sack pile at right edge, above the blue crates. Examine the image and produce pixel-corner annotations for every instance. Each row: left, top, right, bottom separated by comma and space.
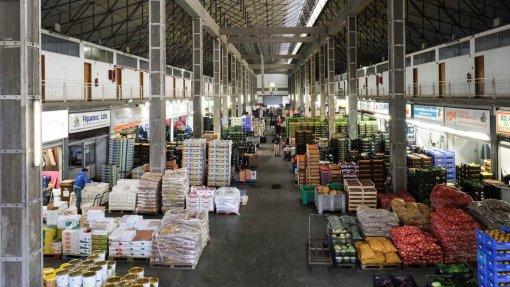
467, 199, 510, 229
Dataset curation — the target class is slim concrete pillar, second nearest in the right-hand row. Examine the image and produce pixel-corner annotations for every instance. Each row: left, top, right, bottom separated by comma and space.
347, 16, 358, 139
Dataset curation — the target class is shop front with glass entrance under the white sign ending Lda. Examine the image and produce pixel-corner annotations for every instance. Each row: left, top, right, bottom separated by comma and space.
66, 110, 111, 179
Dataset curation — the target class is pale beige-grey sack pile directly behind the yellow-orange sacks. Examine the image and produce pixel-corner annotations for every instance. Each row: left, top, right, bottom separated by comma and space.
356, 206, 399, 237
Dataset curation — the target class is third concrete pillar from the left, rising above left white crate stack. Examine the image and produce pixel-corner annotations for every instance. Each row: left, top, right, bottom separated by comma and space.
192, 18, 204, 138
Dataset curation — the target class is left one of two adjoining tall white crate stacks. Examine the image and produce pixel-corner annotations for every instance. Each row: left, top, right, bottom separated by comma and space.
182, 139, 207, 185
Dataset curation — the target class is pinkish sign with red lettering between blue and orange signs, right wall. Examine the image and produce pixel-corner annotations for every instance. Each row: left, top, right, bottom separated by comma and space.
445, 108, 490, 135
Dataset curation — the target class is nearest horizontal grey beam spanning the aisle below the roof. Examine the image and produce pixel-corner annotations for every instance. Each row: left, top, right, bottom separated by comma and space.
220, 27, 327, 36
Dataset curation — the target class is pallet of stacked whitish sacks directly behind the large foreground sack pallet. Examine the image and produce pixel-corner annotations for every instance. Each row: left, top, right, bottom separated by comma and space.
161, 169, 189, 212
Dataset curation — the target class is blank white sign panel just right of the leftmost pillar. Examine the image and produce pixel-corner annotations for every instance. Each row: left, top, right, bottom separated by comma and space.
41, 110, 68, 143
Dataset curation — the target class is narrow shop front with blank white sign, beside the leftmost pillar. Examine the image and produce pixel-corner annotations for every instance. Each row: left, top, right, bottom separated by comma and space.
41, 110, 68, 189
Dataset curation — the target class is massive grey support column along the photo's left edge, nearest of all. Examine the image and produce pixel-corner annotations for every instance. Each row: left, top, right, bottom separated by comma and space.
0, 0, 43, 287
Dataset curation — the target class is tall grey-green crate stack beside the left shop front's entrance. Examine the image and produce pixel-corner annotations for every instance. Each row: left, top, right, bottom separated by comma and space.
108, 138, 135, 179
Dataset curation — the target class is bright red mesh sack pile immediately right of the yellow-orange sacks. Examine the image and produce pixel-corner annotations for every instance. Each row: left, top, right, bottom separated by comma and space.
391, 226, 443, 265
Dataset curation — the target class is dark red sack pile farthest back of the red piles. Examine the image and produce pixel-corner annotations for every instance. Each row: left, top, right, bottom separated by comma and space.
430, 184, 473, 209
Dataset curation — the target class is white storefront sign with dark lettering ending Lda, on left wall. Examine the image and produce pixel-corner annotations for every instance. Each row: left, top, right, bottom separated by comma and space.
69, 111, 110, 134
